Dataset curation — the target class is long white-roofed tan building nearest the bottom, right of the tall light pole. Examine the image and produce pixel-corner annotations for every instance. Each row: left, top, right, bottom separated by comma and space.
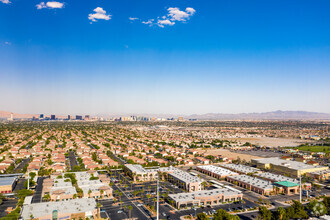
168, 188, 243, 208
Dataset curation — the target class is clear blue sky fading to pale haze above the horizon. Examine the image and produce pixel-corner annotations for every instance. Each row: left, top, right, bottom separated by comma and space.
0, 0, 330, 114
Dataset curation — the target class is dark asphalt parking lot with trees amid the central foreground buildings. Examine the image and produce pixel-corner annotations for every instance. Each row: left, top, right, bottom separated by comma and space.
108, 171, 257, 219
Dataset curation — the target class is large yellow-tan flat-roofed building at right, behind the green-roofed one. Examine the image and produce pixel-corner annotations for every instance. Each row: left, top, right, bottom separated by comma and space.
251, 157, 328, 177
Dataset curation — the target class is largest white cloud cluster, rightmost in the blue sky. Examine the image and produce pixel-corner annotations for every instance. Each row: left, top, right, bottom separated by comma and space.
142, 7, 196, 28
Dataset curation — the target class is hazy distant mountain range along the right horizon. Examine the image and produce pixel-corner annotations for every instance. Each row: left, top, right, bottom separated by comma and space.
188, 111, 330, 120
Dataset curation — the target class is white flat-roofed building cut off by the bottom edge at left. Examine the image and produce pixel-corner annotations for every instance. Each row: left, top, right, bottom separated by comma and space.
21, 198, 97, 220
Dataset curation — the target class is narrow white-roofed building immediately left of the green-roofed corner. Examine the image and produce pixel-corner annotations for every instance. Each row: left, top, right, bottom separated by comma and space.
226, 175, 274, 195
